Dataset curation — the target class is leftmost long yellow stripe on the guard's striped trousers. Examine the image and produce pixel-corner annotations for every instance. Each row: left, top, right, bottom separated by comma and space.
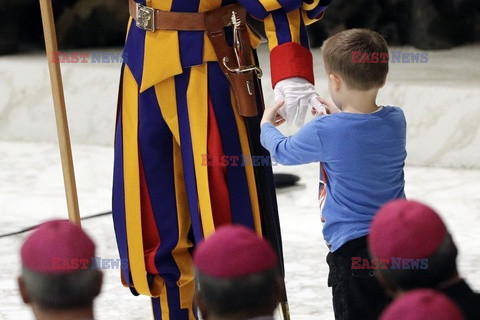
122, 66, 151, 296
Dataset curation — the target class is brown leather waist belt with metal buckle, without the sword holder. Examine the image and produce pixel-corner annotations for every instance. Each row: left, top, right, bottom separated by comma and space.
128, 0, 206, 31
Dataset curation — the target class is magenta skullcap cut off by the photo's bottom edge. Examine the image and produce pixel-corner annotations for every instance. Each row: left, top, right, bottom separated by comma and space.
380, 289, 464, 320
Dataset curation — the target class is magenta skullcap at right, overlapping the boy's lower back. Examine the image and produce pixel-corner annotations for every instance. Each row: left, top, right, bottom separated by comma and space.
368, 199, 447, 262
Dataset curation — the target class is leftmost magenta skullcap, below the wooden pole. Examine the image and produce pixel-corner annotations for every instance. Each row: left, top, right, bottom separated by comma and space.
20, 220, 95, 274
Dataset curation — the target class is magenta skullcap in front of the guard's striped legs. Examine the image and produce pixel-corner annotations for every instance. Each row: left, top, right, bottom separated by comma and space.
193, 225, 278, 278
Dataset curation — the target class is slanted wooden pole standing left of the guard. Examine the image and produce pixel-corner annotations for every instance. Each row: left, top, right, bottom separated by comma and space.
40, 0, 80, 225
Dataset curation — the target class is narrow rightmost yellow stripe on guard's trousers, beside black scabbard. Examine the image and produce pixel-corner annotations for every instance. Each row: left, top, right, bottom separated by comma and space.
230, 92, 262, 235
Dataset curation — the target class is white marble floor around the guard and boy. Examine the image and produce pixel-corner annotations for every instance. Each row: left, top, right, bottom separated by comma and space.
0, 141, 480, 320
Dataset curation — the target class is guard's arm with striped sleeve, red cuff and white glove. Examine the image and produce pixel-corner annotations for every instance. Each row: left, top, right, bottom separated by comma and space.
239, 0, 331, 126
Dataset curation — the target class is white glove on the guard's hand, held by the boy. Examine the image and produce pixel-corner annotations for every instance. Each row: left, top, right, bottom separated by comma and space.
273, 77, 327, 127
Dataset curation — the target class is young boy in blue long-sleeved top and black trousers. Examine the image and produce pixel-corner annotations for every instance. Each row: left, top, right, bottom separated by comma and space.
261, 29, 406, 320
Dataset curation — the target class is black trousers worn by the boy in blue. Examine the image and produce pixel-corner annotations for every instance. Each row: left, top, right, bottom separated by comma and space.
327, 236, 391, 320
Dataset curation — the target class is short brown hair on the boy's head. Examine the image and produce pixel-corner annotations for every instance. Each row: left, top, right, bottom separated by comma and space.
322, 29, 388, 90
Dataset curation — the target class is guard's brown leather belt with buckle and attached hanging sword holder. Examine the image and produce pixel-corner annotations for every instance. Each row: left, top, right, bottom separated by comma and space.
129, 0, 262, 117
